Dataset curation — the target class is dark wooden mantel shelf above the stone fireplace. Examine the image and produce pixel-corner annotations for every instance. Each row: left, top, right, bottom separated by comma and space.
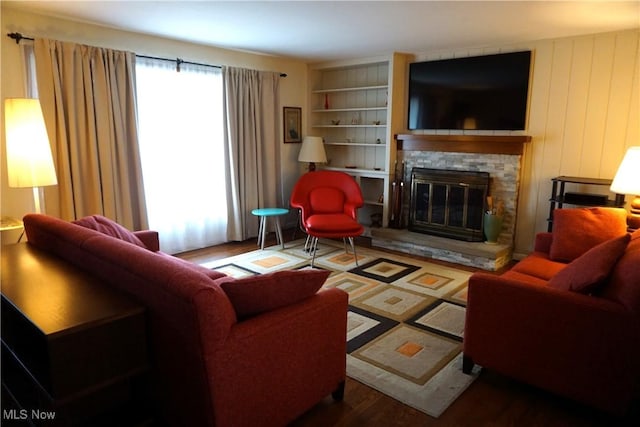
395, 134, 531, 155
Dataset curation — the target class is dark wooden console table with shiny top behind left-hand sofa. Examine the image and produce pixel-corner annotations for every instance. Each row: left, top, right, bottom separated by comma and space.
2, 243, 148, 426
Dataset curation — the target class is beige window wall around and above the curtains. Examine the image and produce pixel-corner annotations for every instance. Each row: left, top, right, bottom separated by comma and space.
0, 3, 307, 243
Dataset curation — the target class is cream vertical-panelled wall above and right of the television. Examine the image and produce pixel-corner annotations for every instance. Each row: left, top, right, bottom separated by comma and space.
416, 30, 640, 255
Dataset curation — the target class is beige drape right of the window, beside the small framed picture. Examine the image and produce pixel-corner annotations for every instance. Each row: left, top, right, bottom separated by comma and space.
224, 67, 286, 240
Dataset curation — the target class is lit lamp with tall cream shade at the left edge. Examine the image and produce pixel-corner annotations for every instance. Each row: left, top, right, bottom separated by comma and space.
4, 98, 58, 213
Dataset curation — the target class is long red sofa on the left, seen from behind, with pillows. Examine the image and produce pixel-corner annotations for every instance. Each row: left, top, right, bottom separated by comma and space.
24, 214, 347, 427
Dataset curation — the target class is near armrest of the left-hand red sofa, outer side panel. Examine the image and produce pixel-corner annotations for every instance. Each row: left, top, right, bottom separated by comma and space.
207, 288, 348, 425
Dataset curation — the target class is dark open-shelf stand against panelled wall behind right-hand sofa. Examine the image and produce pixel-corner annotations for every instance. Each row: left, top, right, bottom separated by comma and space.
547, 176, 624, 231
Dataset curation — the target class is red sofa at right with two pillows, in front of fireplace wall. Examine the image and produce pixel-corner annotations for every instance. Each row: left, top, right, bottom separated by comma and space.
463, 208, 640, 415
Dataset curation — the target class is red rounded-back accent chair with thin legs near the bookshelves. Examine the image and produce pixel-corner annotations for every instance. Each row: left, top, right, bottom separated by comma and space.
290, 170, 364, 267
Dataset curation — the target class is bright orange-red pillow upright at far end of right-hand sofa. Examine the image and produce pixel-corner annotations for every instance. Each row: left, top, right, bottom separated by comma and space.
549, 208, 627, 262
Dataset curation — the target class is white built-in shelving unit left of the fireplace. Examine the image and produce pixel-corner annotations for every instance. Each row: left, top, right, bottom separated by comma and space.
309, 54, 407, 231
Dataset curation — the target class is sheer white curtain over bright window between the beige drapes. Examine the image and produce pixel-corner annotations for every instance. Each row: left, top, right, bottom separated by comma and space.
136, 58, 227, 253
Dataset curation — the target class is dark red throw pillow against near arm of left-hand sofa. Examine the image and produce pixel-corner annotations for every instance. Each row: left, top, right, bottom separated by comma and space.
215, 270, 330, 319
